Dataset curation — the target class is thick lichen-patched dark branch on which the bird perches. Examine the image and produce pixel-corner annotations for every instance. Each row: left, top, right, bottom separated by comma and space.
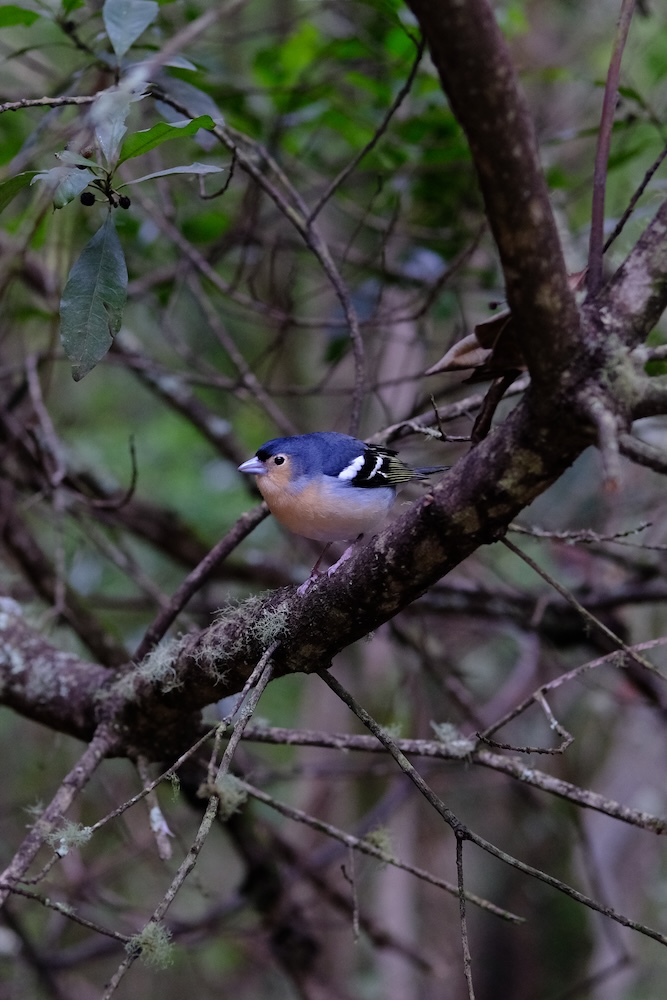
0, 382, 587, 759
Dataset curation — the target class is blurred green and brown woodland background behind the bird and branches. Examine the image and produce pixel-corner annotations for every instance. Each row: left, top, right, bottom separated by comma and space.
0, 0, 667, 1000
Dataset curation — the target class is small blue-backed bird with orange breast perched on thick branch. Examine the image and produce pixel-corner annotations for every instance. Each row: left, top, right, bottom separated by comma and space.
238, 431, 448, 593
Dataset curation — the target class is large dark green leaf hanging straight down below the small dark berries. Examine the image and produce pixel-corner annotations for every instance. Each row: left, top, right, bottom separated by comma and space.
60, 213, 127, 382
